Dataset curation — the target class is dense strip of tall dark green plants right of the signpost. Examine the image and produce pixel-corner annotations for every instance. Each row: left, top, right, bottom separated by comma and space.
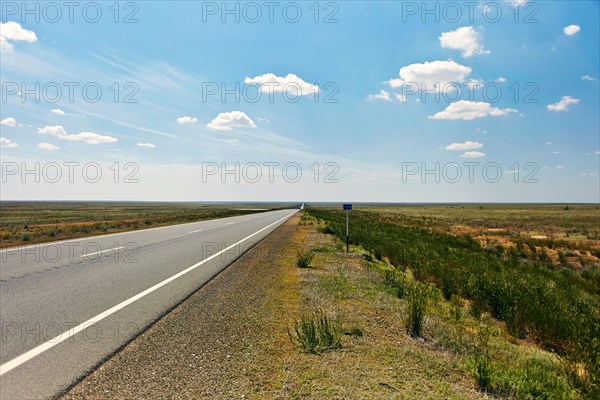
308, 208, 600, 397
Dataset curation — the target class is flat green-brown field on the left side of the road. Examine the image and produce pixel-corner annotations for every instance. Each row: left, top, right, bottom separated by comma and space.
0, 202, 290, 248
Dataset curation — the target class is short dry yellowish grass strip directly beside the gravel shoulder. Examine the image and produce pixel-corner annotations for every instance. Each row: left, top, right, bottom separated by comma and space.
272, 212, 485, 399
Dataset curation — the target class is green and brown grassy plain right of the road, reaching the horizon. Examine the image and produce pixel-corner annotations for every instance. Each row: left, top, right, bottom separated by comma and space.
305, 205, 600, 398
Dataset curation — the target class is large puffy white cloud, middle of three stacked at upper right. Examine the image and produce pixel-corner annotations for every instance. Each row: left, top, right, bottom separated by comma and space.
387, 60, 472, 90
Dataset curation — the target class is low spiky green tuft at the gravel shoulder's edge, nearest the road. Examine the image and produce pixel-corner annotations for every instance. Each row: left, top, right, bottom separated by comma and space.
288, 312, 342, 353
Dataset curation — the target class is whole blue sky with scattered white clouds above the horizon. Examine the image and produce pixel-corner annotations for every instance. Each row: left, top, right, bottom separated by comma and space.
0, 0, 600, 203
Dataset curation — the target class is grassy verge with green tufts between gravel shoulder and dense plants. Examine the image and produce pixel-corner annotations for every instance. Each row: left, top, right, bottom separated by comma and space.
279, 211, 583, 399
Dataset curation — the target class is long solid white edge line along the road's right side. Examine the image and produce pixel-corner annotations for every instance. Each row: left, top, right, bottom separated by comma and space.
0, 211, 296, 376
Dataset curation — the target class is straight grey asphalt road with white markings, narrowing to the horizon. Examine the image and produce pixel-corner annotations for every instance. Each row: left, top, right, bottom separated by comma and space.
0, 210, 298, 399
